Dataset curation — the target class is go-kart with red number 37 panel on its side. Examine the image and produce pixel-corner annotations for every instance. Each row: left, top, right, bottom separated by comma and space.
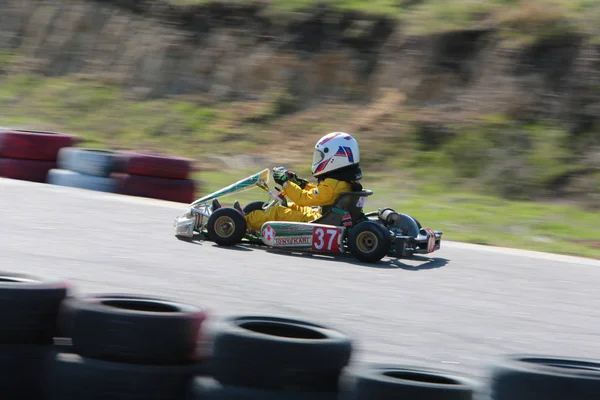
173, 169, 442, 263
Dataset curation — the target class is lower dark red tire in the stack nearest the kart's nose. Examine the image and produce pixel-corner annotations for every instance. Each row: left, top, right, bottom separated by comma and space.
111, 173, 196, 203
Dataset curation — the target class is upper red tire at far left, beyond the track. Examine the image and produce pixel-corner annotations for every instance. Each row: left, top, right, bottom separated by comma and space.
0, 129, 77, 161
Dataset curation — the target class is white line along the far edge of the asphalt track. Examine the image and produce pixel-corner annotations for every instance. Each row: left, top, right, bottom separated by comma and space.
0, 177, 600, 267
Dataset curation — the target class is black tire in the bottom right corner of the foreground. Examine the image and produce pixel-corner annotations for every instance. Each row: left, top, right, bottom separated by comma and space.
489, 355, 600, 400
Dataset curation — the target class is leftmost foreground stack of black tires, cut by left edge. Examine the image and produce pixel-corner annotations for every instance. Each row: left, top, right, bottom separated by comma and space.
0, 272, 69, 400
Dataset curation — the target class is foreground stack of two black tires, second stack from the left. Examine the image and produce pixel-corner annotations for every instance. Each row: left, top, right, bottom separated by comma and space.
44, 294, 207, 400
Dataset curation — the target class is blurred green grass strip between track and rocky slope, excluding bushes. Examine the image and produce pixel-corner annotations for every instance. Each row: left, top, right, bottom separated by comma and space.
0, 70, 600, 259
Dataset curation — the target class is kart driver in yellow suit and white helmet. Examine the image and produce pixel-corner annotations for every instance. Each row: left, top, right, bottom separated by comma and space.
217, 132, 362, 231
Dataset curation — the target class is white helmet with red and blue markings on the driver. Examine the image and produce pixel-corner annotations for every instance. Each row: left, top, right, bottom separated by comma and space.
311, 132, 360, 176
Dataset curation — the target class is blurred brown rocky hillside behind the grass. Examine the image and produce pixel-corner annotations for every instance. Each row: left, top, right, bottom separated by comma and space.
0, 0, 600, 204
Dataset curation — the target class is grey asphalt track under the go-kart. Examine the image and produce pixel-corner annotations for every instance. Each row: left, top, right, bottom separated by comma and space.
0, 179, 600, 384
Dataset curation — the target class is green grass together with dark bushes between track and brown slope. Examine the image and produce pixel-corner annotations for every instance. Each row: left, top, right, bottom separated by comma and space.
0, 70, 600, 258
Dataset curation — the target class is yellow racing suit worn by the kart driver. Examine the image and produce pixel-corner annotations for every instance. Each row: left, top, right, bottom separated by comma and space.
246, 178, 352, 231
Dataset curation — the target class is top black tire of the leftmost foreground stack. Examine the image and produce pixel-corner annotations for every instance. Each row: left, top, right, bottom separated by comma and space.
0, 272, 70, 344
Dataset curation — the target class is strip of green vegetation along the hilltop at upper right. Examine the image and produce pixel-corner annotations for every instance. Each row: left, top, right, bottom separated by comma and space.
170, 0, 600, 42
